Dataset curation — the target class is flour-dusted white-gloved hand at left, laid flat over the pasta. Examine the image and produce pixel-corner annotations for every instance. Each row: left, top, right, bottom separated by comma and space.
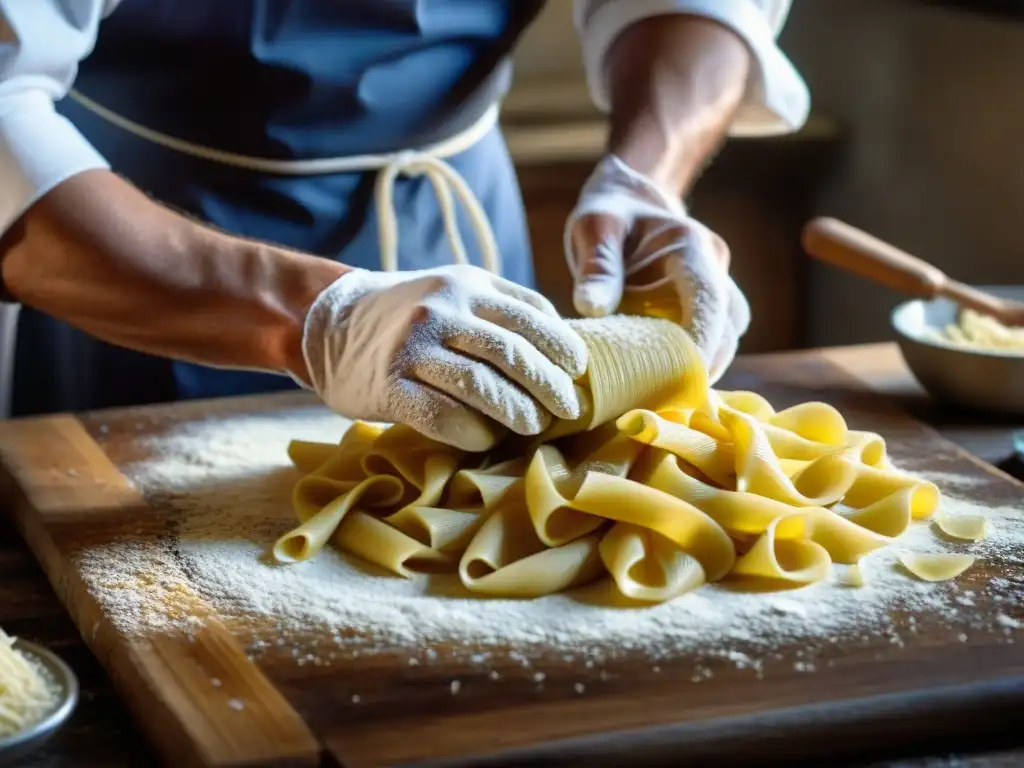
303, 265, 587, 451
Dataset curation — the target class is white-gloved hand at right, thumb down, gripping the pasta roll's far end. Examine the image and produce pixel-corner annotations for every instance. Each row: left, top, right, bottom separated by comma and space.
565, 155, 751, 383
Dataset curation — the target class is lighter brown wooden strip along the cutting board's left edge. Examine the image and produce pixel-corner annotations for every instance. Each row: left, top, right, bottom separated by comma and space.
0, 416, 319, 765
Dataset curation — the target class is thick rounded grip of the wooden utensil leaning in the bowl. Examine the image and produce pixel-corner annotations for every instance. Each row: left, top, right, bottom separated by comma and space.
803, 217, 949, 299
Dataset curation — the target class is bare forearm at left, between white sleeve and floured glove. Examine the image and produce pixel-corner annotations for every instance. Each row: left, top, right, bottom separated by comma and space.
0, 170, 346, 378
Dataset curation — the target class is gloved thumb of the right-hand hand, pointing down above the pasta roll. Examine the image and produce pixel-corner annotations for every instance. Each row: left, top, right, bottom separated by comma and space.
567, 214, 626, 317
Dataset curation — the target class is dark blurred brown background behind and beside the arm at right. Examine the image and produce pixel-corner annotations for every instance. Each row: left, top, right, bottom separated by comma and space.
505, 0, 1024, 351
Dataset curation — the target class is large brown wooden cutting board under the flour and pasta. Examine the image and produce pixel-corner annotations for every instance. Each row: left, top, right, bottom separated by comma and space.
0, 353, 1024, 767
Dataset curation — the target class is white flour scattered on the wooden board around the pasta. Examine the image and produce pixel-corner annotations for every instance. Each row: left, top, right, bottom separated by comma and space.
74, 408, 1024, 679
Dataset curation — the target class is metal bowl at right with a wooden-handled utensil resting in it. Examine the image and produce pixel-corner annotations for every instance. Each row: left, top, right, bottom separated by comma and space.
892, 286, 1024, 416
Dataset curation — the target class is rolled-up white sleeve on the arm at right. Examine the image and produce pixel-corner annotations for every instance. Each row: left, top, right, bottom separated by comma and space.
575, 0, 811, 136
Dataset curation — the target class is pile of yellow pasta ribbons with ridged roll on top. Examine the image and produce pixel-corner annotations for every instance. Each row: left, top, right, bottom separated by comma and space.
273, 315, 985, 603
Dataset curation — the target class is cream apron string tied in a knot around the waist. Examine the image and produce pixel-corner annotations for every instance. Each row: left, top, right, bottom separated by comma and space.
68, 89, 501, 274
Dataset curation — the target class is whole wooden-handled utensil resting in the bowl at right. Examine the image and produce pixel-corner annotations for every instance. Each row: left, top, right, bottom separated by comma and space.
802, 217, 1024, 326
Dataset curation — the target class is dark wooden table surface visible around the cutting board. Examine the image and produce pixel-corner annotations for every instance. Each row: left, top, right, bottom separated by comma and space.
6, 345, 1024, 768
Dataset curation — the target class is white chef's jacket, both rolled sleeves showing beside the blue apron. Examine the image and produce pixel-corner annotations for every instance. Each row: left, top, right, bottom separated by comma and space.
0, 0, 810, 239
